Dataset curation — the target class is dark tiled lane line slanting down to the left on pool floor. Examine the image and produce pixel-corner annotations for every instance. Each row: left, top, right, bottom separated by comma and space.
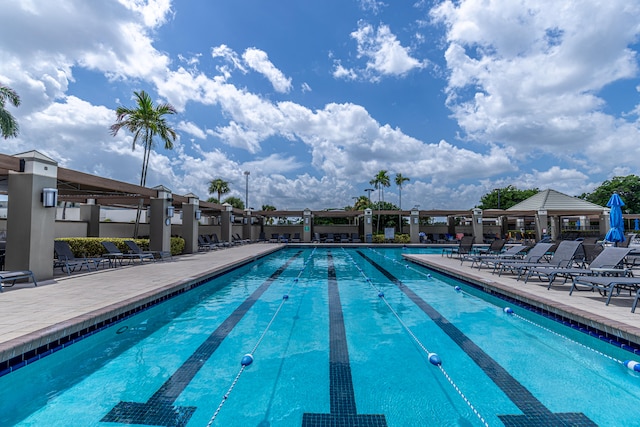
100, 251, 302, 427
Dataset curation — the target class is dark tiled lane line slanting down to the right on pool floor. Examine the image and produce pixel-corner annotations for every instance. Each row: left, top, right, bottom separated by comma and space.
357, 251, 597, 427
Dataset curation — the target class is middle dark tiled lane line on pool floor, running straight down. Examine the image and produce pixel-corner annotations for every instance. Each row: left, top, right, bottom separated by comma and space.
302, 252, 387, 427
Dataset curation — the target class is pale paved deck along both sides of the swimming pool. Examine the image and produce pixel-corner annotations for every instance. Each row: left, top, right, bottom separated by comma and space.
0, 243, 640, 375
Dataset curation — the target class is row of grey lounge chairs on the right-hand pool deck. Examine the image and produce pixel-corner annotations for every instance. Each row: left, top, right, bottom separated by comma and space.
456, 240, 640, 312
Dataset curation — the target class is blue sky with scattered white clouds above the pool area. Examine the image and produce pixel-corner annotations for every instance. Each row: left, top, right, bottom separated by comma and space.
0, 0, 640, 210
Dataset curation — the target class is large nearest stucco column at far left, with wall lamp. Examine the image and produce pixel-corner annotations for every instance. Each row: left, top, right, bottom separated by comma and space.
5, 151, 58, 280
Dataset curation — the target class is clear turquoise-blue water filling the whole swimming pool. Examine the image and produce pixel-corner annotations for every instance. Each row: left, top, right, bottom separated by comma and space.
0, 247, 640, 427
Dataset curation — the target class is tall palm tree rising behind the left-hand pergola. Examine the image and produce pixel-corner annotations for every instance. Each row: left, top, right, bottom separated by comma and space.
111, 91, 177, 237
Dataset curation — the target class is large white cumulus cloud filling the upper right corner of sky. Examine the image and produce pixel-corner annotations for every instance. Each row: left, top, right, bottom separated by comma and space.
431, 0, 640, 162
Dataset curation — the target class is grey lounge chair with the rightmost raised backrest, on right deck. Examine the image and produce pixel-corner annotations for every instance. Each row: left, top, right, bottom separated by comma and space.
536, 246, 630, 289
